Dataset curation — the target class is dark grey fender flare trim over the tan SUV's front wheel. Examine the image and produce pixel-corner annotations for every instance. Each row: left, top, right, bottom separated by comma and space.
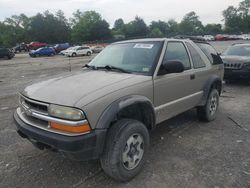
96, 95, 156, 129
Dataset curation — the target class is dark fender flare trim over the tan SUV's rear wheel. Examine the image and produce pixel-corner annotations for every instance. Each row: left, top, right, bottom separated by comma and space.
199, 75, 222, 106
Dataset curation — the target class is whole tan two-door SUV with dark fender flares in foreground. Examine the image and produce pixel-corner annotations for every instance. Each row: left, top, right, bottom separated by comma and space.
14, 39, 224, 181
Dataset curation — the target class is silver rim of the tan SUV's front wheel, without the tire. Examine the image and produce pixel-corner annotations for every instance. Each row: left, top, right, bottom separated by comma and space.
122, 133, 144, 170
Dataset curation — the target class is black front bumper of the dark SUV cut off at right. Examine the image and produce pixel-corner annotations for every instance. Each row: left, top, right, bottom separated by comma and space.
224, 67, 250, 79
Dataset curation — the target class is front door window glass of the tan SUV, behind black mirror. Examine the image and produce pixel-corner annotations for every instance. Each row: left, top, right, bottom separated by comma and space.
163, 42, 191, 70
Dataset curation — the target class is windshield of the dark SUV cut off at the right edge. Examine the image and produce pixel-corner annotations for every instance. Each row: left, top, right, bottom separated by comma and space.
223, 45, 250, 56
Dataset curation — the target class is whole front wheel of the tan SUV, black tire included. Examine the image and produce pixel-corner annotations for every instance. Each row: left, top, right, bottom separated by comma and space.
101, 119, 149, 182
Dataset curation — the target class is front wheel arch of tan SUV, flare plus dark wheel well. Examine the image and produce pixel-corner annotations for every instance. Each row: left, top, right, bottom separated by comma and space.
96, 95, 156, 130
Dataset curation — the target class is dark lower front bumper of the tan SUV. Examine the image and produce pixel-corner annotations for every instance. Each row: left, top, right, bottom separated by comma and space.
14, 112, 107, 161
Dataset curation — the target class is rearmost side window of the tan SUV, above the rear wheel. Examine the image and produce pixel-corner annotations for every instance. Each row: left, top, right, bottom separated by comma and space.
196, 43, 223, 65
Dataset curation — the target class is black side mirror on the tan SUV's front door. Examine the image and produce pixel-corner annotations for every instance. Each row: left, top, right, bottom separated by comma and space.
160, 60, 185, 75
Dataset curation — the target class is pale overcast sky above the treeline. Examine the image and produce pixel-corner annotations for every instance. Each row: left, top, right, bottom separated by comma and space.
0, 0, 243, 26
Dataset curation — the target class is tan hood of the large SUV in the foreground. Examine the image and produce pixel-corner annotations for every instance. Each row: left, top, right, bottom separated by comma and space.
22, 69, 149, 107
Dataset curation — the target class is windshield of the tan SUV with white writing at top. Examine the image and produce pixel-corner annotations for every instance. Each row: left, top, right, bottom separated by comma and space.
89, 42, 163, 74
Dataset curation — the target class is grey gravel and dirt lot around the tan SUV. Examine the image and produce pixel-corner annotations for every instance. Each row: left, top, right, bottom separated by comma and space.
0, 42, 250, 188
